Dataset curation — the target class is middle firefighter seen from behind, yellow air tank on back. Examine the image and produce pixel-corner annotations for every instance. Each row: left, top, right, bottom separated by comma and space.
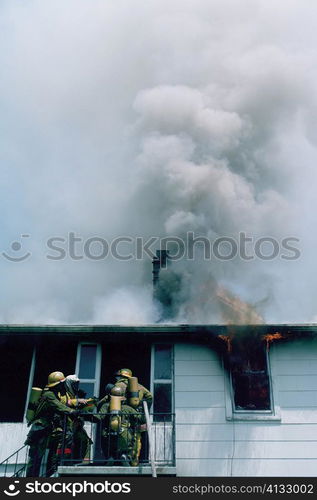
99, 387, 140, 465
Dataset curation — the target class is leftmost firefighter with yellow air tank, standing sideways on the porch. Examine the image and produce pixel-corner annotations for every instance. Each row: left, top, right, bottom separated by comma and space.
25, 371, 77, 477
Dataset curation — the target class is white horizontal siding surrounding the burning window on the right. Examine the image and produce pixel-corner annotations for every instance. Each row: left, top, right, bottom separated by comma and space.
175, 339, 317, 477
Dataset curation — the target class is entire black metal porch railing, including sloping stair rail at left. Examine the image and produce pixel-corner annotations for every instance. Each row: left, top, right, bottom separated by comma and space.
0, 413, 175, 477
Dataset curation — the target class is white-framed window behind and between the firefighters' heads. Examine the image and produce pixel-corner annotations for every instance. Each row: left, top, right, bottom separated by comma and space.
76, 342, 101, 398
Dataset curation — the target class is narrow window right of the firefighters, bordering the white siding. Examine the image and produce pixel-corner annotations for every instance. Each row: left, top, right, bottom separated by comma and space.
152, 344, 173, 421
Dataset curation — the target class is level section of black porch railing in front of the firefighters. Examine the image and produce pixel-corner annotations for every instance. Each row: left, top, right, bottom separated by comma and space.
59, 413, 175, 466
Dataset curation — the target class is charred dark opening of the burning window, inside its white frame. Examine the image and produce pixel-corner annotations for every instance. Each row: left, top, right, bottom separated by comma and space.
229, 339, 272, 412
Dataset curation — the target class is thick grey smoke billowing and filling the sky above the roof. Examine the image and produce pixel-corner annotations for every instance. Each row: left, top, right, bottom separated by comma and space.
0, 0, 317, 324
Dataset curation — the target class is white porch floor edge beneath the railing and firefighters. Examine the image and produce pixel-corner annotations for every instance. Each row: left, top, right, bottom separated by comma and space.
57, 465, 176, 477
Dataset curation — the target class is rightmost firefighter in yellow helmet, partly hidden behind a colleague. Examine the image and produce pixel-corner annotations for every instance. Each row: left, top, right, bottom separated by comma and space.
115, 368, 153, 467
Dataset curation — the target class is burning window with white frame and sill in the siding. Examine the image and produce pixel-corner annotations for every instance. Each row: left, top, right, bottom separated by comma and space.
227, 338, 279, 420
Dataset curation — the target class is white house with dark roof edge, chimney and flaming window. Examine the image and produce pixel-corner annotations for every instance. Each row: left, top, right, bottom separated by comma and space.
0, 254, 317, 476
